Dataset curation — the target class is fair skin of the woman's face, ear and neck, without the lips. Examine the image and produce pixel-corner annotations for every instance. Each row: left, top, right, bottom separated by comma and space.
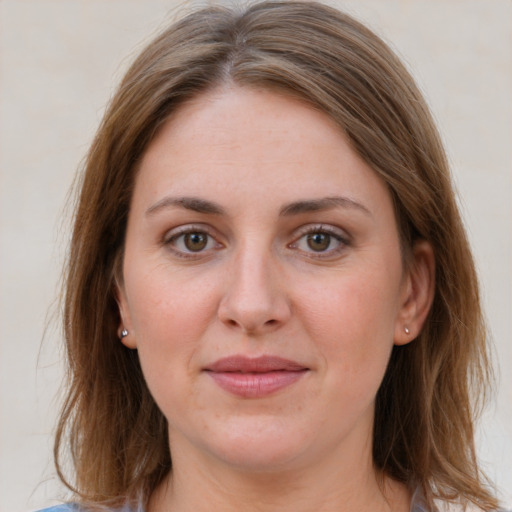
118, 87, 434, 512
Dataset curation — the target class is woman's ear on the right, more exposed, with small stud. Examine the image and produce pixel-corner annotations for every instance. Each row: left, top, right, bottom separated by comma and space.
394, 240, 435, 345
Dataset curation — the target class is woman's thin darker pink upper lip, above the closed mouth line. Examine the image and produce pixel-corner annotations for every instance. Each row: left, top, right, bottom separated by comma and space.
205, 355, 308, 373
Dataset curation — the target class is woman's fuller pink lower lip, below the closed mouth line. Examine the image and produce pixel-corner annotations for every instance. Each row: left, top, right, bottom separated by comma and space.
208, 370, 307, 398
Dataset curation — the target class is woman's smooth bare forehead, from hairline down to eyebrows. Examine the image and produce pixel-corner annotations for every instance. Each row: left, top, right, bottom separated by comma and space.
132, 87, 389, 216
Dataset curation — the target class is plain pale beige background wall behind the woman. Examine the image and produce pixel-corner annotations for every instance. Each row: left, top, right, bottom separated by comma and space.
0, 0, 512, 512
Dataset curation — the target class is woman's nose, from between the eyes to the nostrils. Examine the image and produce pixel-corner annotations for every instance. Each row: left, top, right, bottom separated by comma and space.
218, 245, 291, 336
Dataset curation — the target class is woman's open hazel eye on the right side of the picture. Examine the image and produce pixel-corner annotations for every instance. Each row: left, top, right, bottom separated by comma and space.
289, 226, 348, 257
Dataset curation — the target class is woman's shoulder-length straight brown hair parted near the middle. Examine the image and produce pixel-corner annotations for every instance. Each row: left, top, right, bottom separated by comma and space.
55, 1, 497, 510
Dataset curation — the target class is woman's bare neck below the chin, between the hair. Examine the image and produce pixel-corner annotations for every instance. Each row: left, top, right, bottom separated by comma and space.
148, 432, 411, 512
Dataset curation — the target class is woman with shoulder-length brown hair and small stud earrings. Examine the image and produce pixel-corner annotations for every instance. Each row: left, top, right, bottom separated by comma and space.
44, 2, 504, 512
